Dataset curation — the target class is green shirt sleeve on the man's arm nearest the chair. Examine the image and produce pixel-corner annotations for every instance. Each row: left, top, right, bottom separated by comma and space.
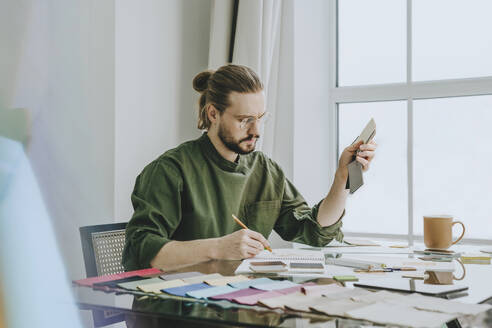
122, 161, 182, 271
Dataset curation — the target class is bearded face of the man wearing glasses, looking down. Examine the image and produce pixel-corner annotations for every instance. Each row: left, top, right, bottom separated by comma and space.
218, 91, 265, 154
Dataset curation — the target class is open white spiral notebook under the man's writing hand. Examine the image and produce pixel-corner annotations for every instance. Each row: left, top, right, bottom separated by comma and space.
234, 248, 325, 274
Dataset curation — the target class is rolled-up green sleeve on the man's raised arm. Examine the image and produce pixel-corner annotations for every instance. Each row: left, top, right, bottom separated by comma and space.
274, 178, 345, 247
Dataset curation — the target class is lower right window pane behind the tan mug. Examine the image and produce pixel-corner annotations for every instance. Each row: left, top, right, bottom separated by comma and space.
414, 96, 492, 239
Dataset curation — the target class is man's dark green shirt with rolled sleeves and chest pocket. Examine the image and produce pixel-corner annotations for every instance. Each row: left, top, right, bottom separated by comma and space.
123, 134, 343, 270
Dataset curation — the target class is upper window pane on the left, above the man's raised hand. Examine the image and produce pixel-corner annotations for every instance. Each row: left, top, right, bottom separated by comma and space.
338, 0, 406, 86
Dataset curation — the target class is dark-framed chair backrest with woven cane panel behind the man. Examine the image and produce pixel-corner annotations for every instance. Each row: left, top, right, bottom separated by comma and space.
79, 222, 126, 277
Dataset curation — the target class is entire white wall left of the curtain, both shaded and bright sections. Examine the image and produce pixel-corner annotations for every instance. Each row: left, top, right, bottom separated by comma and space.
0, 0, 210, 279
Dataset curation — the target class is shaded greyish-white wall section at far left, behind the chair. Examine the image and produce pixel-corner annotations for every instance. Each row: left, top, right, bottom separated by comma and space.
0, 0, 114, 278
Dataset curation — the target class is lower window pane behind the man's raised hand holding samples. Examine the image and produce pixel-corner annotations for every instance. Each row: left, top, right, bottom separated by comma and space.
339, 101, 408, 234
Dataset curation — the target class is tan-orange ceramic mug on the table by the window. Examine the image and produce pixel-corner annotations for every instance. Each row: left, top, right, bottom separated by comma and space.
424, 215, 465, 250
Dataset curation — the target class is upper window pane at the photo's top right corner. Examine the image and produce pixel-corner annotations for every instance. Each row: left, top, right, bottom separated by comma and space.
412, 0, 492, 81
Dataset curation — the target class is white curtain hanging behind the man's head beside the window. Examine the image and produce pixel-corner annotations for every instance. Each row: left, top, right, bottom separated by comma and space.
209, 0, 294, 178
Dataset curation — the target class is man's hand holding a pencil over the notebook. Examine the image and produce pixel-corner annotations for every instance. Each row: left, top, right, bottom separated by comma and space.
217, 229, 270, 260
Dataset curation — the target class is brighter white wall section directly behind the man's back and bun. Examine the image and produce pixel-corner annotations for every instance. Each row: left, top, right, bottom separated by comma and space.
115, 0, 211, 221
